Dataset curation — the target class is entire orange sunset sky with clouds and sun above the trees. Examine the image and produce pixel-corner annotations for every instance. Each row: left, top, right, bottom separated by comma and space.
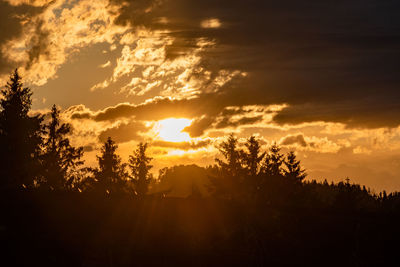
0, 0, 400, 191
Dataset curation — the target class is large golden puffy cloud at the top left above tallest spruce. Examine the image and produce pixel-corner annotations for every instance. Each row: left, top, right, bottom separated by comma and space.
1, 0, 127, 85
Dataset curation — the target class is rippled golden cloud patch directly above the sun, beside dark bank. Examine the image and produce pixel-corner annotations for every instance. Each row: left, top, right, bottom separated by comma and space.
92, 30, 236, 98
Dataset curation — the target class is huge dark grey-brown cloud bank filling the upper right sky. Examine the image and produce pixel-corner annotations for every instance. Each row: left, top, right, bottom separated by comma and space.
110, 0, 400, 129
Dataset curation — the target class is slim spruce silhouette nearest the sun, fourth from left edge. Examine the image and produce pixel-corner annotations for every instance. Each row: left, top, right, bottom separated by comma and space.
129, 143, 153, 197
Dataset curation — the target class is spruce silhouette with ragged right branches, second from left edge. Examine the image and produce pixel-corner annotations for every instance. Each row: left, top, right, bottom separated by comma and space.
42, 105, 83, 189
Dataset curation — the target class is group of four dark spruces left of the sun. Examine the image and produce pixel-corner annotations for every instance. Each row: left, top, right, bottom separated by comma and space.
0, 70, 155, 196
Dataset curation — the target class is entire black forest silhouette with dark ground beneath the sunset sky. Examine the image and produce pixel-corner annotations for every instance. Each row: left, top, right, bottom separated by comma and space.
0, 70, 400, 266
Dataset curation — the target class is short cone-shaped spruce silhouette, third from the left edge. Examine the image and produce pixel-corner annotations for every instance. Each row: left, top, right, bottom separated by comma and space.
94, 137, 128, 194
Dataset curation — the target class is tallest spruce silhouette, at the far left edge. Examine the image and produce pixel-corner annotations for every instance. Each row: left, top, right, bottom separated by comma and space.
0, 70, 43, 189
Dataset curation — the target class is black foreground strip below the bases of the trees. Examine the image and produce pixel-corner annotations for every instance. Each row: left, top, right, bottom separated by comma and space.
0, 192, 400, 266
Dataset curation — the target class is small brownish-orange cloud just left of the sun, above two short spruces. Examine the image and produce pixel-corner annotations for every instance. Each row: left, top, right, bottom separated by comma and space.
99, 121, 147, 143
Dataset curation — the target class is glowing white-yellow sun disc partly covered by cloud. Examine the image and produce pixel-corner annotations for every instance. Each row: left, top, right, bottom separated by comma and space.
155, 118, 192, 142
